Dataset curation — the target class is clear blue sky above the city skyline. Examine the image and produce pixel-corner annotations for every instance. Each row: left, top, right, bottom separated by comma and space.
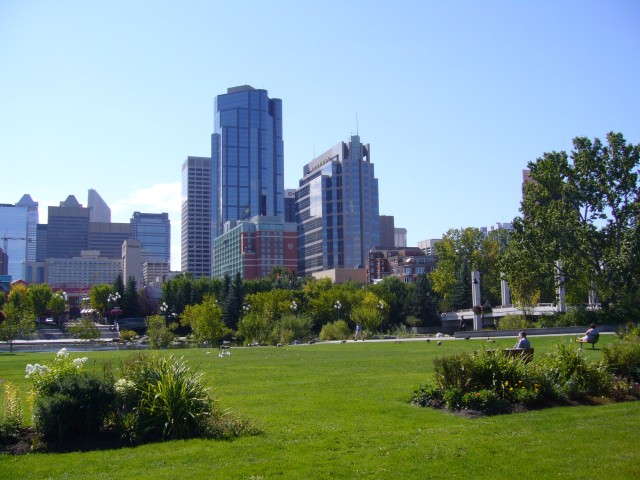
0, 0, 640, 269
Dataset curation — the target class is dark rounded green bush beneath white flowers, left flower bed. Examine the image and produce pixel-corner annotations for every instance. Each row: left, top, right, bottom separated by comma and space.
34, 372, 115, 443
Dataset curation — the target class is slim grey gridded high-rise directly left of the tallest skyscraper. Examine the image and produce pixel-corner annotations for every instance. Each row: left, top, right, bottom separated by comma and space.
180, 157, 213, 278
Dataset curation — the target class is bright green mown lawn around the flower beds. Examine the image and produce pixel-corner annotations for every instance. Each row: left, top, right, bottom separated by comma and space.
0, 335, 640, 480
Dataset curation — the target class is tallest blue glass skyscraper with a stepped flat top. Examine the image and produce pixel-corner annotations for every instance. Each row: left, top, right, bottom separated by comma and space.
211, 85, 284, 238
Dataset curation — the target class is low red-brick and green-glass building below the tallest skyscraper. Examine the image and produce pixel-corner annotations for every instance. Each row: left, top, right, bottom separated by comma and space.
212, 216, 298, 280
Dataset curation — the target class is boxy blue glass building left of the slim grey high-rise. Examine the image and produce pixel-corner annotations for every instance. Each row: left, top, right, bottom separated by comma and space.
131, 212, 171, 263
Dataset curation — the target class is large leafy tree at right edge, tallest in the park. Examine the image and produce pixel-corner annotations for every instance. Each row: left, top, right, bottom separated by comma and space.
504, 132, 640, 318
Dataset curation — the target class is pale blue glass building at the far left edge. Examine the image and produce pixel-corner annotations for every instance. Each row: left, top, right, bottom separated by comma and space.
0, 195, 38, 281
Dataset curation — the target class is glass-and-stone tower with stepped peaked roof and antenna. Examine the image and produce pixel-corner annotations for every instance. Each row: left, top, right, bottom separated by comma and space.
296, 135, 380, 275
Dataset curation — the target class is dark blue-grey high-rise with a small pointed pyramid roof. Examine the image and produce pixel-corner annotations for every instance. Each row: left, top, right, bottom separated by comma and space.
46, 195, 89, 258
